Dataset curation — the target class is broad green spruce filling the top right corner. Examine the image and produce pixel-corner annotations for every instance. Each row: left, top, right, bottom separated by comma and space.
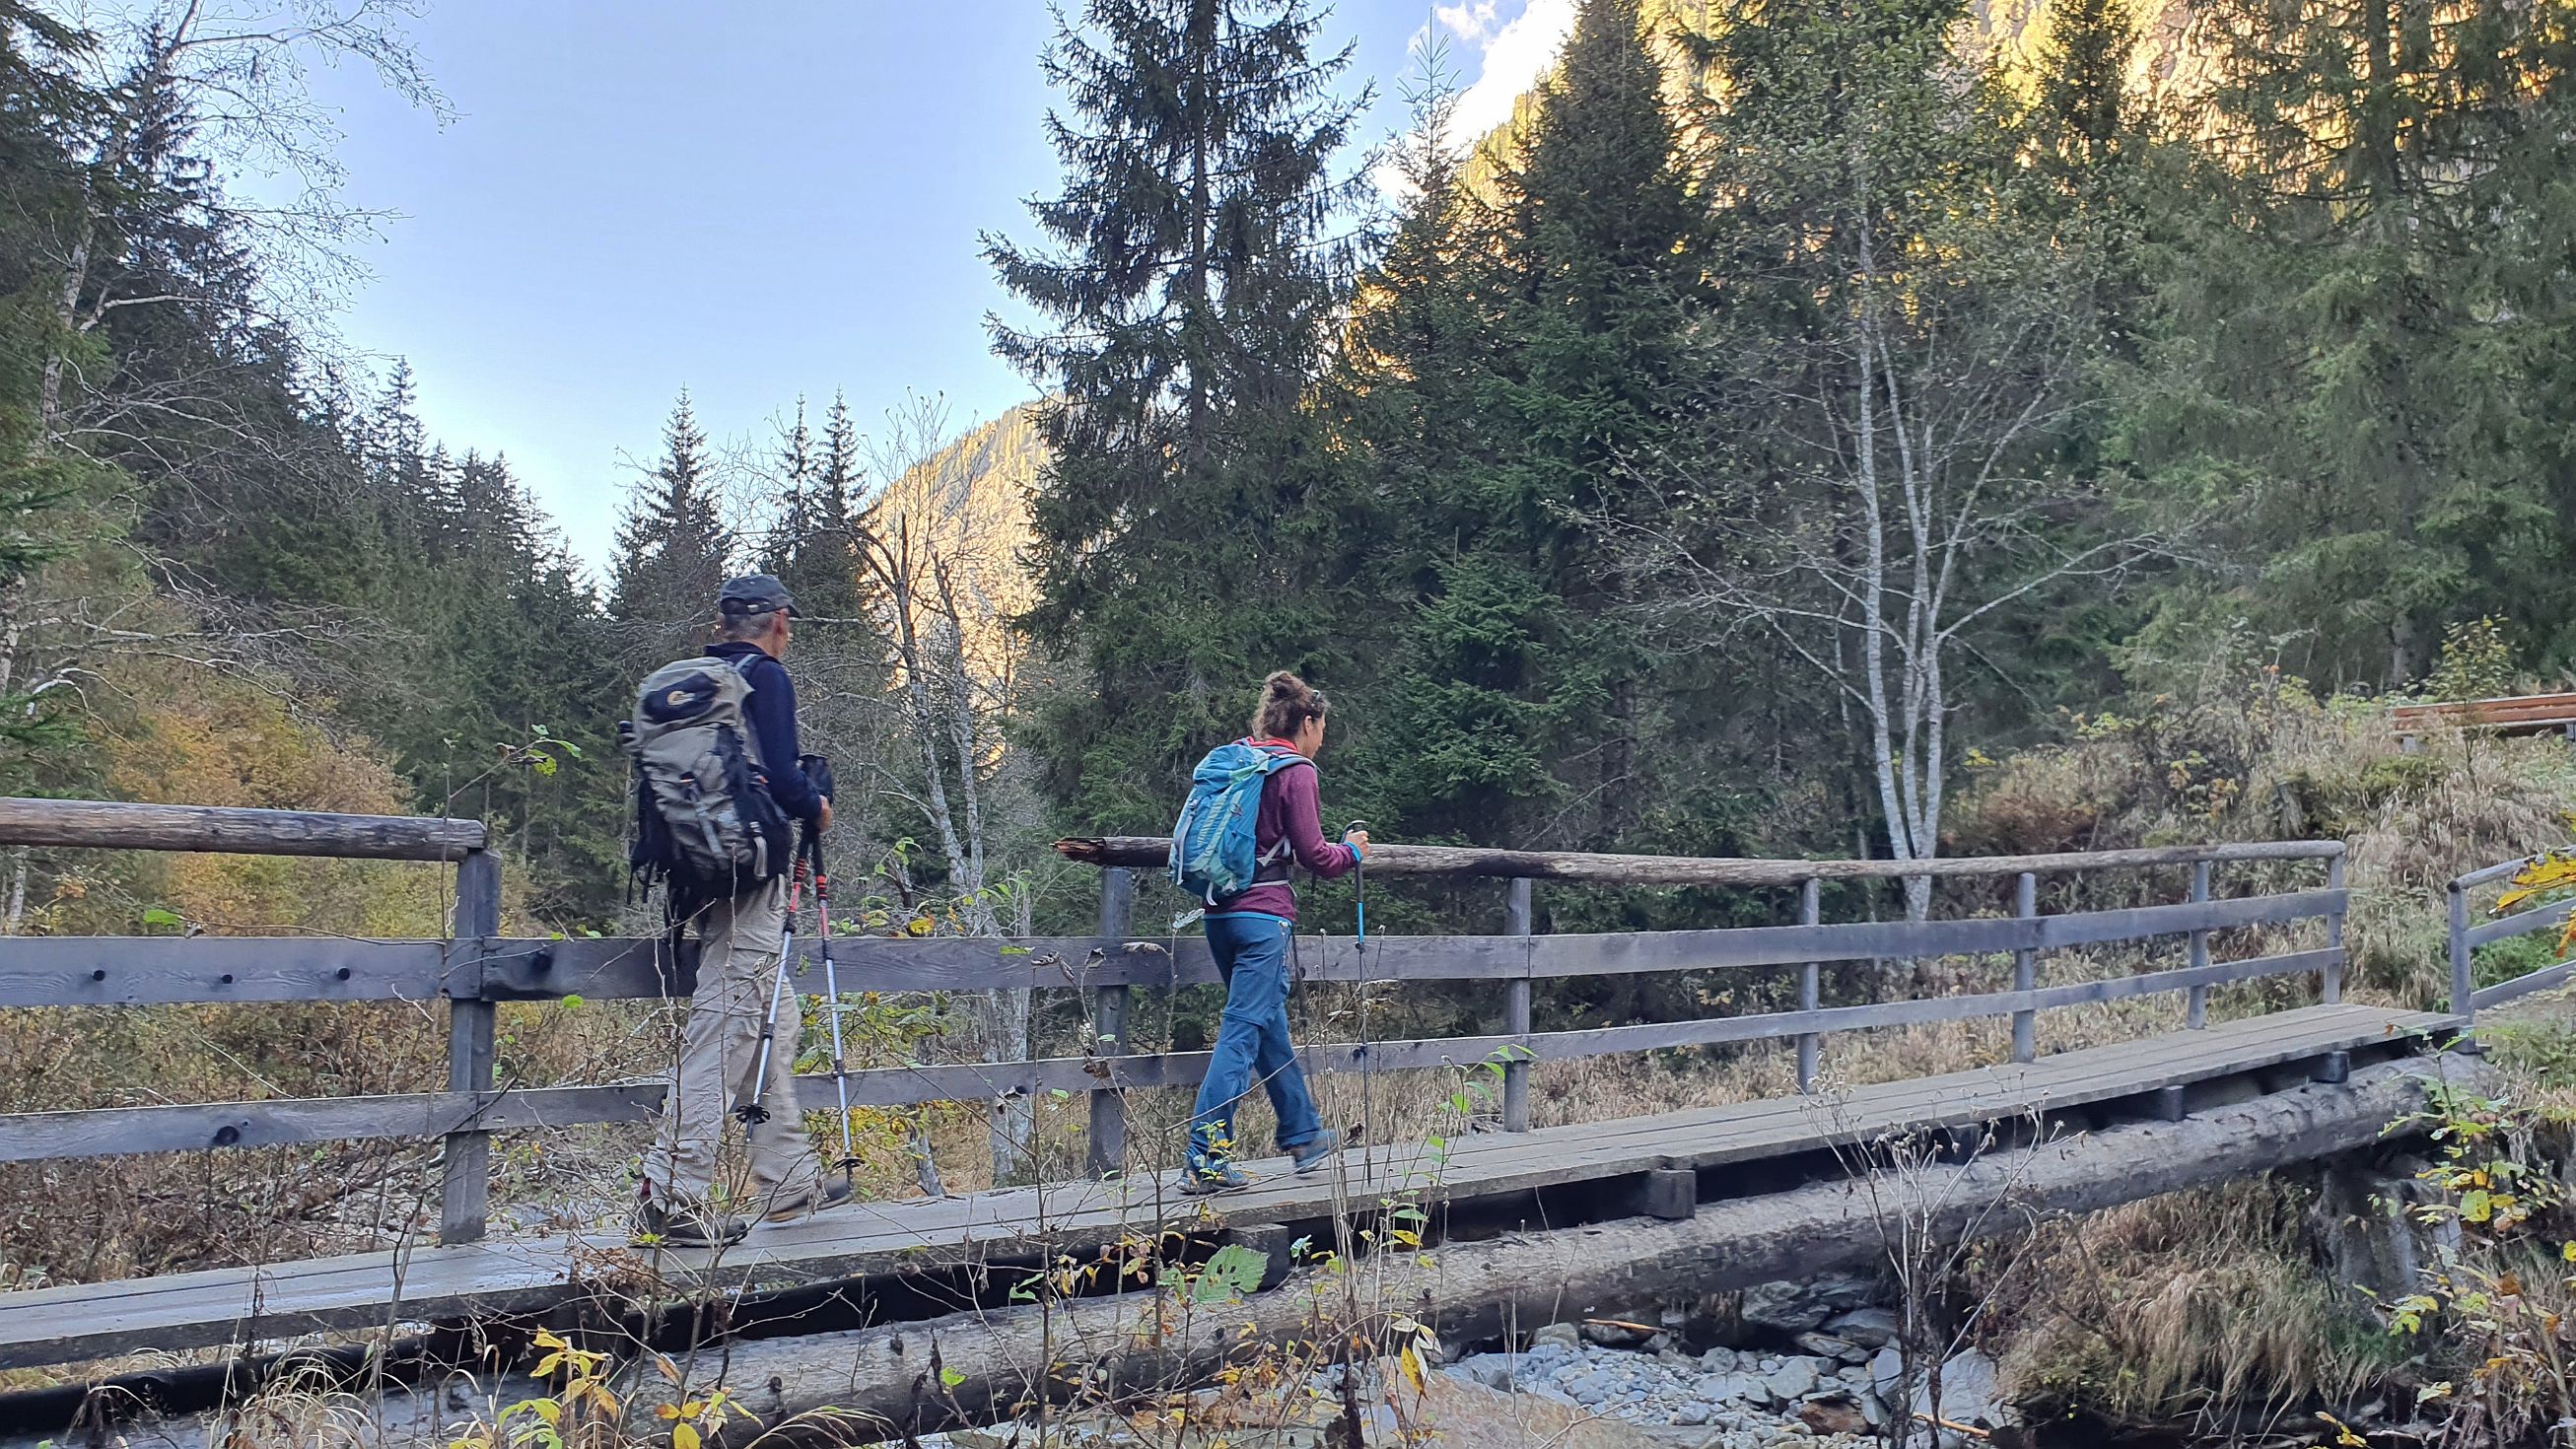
2127, 0, 2576, 687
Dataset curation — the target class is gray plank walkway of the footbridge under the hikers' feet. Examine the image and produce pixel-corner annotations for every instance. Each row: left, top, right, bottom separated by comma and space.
0, 1003, 2455, 1366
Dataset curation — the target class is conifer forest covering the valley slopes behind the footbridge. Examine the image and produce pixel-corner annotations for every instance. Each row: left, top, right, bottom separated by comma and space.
20, 0, 2576, 930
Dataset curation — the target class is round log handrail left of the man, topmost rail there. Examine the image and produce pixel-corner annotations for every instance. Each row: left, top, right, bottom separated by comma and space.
0, 797, 487, 860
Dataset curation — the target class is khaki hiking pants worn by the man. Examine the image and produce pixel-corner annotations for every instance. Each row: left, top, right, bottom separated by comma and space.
644, 877, 822, 1212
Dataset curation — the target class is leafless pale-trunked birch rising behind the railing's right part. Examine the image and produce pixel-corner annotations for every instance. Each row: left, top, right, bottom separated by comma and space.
1608, 0, 2153, 919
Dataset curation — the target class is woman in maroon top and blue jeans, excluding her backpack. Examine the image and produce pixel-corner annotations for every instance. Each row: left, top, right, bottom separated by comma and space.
1182, 669, 1368, 1195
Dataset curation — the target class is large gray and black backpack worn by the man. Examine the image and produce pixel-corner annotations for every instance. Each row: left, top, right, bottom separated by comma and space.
621, 654, 794, 898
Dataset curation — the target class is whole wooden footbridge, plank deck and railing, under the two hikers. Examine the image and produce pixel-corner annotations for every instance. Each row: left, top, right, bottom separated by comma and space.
0, 800, 2468, 1441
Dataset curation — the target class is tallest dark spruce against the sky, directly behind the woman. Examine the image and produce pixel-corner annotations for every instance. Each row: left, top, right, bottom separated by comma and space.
984, 0, 1362, 826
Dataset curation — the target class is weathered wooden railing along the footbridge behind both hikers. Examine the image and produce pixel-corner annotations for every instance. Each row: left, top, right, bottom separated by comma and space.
0, 800, 2346, 1243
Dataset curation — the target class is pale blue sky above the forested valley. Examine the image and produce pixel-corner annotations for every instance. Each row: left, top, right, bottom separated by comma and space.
276, 0, 1574, 564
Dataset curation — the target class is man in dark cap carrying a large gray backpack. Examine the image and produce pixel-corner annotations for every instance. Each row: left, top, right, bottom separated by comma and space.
634, 574, 850, 1246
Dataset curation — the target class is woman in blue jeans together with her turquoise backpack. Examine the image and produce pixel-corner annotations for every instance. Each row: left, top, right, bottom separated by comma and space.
1172, 669, 1368, 1195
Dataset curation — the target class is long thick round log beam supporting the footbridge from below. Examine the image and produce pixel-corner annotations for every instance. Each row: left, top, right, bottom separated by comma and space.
669, 1066, 2472, 1441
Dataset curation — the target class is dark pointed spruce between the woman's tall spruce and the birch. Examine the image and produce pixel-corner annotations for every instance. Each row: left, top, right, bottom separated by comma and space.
1350, 0, 1706, 844
